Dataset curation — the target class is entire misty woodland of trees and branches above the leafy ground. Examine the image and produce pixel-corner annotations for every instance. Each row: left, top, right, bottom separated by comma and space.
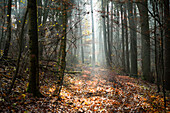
0, 0, 170, 100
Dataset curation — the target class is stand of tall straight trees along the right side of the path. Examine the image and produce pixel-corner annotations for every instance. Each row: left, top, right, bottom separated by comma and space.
98, 0, 169, 89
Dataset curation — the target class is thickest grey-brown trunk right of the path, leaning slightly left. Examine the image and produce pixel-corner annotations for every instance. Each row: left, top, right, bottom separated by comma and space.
137, 0, 152, 82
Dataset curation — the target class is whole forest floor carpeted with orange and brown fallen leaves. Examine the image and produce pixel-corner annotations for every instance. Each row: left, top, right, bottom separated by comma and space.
0, 66, 170, 113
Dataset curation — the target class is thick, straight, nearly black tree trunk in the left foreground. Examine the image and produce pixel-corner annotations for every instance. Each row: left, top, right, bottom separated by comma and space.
27, 0, 42, 97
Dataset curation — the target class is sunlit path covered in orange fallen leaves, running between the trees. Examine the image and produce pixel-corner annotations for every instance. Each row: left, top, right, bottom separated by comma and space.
49, 67, 168, 113
